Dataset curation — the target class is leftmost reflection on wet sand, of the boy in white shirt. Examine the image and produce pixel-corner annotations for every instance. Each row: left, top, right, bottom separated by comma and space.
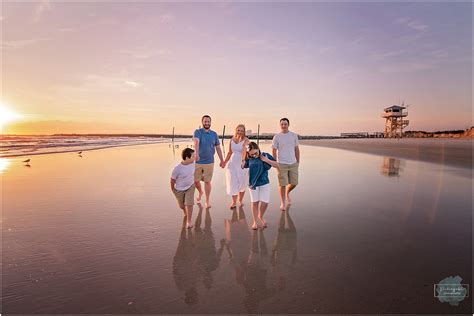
173, 219, 198, 305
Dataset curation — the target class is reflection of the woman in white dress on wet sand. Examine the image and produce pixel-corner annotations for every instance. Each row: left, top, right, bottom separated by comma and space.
224, 206, 251, 285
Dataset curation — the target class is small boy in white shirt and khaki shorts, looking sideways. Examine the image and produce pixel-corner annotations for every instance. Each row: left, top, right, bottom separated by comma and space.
170, 148, 196, 228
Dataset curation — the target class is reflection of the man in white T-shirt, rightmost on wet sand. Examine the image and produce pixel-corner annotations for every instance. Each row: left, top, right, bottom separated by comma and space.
272, 208, 297, 290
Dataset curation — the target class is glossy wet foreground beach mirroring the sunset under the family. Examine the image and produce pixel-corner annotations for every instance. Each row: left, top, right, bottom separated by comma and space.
0, 143, 472, 314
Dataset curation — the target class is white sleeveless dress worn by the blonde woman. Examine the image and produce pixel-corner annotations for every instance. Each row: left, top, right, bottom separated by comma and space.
225, 139, 249, 195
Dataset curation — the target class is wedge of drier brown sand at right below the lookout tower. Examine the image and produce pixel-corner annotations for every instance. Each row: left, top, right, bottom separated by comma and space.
301, 138, 473, 168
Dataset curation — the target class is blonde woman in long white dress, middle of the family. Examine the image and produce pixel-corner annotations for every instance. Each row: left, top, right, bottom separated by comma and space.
224, 124, 249, 209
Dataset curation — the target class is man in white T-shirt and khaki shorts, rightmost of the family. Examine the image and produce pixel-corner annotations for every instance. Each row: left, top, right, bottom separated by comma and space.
272, 117, 300, 211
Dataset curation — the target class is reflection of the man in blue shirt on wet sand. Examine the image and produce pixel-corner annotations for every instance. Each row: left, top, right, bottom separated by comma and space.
194, 204, 224, 290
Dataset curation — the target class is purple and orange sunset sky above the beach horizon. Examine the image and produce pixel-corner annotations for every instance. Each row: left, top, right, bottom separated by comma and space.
0, 1, 473, 135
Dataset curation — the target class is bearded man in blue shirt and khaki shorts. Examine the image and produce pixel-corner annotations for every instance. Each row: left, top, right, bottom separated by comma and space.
194, 115, 224, 208
